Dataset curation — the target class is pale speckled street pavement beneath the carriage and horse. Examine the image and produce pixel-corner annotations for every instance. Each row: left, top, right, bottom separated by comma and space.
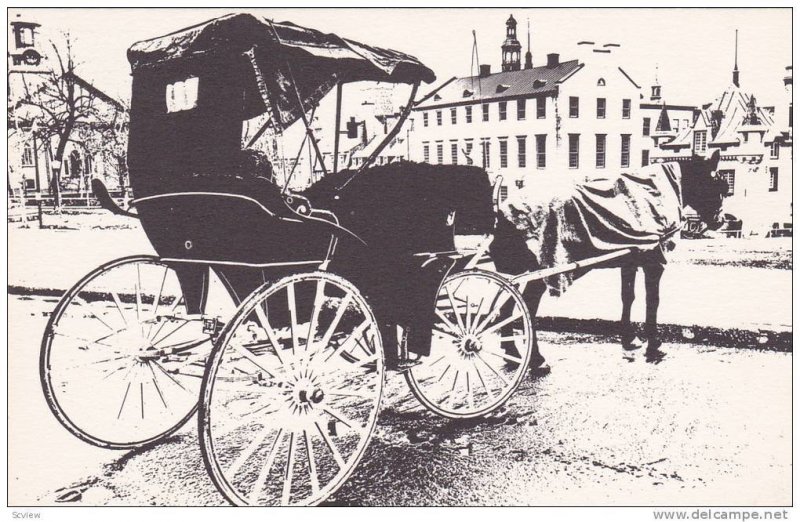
9, 297, 792, 505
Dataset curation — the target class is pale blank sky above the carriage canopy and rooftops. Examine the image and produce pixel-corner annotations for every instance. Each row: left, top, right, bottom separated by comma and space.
8, 7, 792, 105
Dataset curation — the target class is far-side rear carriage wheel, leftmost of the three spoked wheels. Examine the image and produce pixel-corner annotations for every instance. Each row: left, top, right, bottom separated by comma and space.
39, 256, 213, 449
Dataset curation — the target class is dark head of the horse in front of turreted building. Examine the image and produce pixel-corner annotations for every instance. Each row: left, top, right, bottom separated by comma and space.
681, 146, 728, 230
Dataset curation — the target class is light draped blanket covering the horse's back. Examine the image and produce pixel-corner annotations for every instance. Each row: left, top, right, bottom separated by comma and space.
500, 163, 683, 295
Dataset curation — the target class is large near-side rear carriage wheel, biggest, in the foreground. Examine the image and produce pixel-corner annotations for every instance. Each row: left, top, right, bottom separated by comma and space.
199, 272, 383, 505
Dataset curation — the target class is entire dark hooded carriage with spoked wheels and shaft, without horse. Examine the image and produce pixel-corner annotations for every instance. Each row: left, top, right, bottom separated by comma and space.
40, 15, 720, 505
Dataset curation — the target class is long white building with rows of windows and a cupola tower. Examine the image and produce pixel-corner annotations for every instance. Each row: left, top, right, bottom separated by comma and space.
411, 16, 642, 197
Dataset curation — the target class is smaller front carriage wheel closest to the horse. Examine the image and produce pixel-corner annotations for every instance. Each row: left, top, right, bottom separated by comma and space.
406, 270, 534, 418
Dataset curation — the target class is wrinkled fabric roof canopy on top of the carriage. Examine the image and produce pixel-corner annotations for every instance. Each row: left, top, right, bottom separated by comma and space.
128, 14, 436, 129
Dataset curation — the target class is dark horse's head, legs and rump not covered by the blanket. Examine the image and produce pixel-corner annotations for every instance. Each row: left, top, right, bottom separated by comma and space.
490, 151, 726, 370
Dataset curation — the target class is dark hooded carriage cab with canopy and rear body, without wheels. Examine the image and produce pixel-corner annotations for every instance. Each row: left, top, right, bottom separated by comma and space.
128, 14, 435, 307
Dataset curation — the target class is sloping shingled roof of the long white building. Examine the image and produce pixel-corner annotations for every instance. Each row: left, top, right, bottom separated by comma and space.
415, 60, 583, 110
